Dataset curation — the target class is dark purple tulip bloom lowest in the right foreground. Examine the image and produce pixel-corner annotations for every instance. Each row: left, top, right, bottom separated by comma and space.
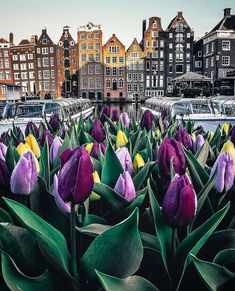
162, 174, 197, 228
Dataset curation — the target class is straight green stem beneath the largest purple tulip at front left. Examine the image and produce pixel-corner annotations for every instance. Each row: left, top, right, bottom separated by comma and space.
70, 202, 78, 290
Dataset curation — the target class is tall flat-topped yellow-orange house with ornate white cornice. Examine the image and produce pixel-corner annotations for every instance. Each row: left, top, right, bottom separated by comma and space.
78, 22, 103, 100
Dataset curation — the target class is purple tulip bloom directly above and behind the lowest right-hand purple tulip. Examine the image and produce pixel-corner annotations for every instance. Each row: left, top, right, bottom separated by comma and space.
158, 138, 186, 178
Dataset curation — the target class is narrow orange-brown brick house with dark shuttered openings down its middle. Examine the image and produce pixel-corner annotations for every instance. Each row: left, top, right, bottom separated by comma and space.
57, 26, 77, 97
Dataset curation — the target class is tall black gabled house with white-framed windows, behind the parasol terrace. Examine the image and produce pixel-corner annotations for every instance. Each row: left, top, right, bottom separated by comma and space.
166, 12, 194, 93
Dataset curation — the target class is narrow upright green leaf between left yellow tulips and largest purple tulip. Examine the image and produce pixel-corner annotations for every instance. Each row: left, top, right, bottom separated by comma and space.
39, 139, 50, 189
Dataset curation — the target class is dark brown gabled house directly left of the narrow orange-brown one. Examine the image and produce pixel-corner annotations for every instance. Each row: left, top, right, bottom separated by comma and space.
36, 28, 57, 97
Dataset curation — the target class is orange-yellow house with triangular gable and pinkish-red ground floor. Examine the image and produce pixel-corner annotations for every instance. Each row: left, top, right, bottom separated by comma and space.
103, 34, 127, 100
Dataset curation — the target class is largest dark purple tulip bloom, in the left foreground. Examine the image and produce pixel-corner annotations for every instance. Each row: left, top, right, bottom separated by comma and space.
54, 147, 94, 204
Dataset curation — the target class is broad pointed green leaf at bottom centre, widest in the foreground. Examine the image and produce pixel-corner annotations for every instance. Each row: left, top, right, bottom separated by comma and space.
81, 209, 143, 278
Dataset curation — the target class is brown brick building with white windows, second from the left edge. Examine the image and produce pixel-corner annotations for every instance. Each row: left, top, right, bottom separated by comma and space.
11, 35, 38, 94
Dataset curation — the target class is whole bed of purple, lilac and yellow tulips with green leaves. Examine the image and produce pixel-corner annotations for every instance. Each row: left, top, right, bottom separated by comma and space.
0, 107, 235, 291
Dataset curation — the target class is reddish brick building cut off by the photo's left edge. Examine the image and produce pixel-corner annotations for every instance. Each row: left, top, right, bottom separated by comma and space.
0, 34, 14, 99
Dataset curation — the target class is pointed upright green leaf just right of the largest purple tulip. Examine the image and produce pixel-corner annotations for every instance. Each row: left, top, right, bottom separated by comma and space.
101, 142, 124, 188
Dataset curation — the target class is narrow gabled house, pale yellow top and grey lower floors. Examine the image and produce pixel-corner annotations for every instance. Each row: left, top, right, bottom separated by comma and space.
126, 38, 144, 100
